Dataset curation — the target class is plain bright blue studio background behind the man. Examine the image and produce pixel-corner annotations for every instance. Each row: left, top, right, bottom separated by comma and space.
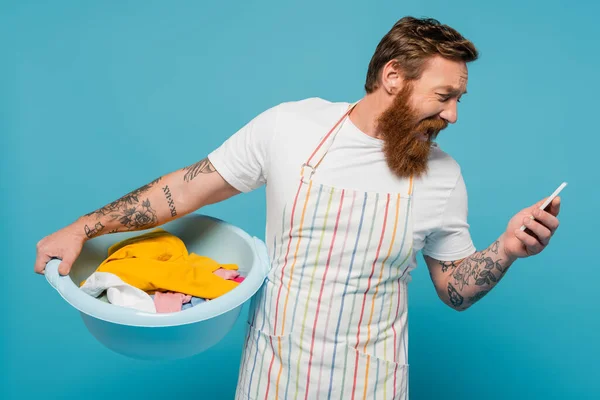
0, 0, 600, 400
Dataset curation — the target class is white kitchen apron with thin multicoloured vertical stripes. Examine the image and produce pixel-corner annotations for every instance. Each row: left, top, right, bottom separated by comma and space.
236, 106, 414, 400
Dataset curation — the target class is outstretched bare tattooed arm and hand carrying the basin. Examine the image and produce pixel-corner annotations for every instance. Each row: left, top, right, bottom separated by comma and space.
34, 158, 239, 274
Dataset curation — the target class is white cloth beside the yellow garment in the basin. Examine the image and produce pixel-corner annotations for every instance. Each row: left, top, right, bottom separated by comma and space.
80, 272, 156, 313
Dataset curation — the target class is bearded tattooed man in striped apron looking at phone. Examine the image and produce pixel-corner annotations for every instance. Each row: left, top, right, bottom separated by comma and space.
35, 17, 560, 399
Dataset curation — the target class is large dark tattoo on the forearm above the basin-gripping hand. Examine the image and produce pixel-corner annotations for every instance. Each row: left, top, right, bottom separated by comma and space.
84, 178, 161, 233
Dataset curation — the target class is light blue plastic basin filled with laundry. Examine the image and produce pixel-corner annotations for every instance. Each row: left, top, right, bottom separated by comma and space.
45, 214, 269, 360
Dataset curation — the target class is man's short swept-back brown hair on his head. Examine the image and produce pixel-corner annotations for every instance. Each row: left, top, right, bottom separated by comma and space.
365, 17, 479, 93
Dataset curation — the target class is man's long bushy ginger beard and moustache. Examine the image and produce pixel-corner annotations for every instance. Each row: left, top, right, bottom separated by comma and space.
377, 83, 448, 178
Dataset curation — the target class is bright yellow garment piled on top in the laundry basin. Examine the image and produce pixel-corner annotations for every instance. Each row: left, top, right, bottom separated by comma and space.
81, 229, 239, 299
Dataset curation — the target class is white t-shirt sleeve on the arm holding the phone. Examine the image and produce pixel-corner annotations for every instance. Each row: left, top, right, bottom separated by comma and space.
422, 173, 477, 261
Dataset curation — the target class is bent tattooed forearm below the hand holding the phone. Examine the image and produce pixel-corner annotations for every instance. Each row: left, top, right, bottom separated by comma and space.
425, 238, 515, 311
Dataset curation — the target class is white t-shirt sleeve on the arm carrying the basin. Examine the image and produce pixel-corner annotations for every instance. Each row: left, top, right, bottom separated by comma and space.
208, 102, 278, 193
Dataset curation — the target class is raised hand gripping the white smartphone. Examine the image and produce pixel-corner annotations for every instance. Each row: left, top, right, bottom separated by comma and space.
503, 196, 560, 259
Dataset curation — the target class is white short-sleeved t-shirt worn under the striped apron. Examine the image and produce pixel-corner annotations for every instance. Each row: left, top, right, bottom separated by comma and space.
208, 98, 476, 268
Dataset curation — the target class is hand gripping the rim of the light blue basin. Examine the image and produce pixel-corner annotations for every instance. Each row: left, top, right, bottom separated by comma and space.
34, 226, 87, 275
